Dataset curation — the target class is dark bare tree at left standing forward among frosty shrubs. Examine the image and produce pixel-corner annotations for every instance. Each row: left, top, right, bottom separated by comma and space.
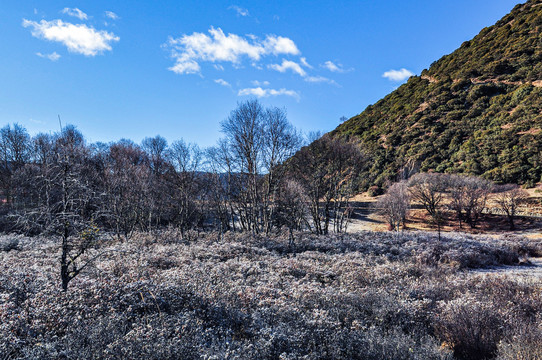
13, 126, 105, 291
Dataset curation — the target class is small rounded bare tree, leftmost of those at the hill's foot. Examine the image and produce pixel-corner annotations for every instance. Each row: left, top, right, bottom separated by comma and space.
377, 182, 410, 231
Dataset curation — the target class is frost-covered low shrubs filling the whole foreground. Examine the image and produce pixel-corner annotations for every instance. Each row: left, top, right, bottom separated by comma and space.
0, 229, 542, 359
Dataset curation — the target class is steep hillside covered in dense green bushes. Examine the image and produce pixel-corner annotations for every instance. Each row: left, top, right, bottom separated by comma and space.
331, 0, 542, 187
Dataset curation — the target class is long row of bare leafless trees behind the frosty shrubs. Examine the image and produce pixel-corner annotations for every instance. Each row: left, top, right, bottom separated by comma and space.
0, 100, 363, 289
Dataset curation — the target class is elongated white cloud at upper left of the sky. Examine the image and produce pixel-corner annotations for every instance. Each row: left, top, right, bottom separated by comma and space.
22, 19, 120, 56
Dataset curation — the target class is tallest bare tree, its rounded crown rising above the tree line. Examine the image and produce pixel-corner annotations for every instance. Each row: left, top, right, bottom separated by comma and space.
218, 100, 302, 233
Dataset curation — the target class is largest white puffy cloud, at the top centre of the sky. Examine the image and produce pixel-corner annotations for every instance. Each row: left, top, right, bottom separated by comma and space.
164, 27, 299, 74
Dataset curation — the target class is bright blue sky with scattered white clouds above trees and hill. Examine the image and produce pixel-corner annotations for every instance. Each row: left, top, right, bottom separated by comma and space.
0, 0, 519, 146
